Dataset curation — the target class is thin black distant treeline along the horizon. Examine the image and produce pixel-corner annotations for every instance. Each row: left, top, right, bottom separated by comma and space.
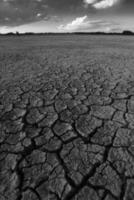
0, 30, 134, 36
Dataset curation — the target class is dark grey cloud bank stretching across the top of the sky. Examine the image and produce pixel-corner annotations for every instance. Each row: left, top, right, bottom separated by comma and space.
0, 0, 134, 31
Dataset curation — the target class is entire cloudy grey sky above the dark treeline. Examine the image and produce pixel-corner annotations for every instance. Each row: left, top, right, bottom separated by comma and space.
0, 0, 134, 33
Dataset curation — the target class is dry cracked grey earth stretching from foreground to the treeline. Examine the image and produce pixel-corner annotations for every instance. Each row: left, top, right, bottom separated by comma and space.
0, 36, 134, 200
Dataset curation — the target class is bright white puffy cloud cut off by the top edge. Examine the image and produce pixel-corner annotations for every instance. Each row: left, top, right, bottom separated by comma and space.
84, 0, 120, 9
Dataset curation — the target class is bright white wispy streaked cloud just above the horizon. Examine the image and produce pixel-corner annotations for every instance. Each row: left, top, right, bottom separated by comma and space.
58, 15, 118, 32
